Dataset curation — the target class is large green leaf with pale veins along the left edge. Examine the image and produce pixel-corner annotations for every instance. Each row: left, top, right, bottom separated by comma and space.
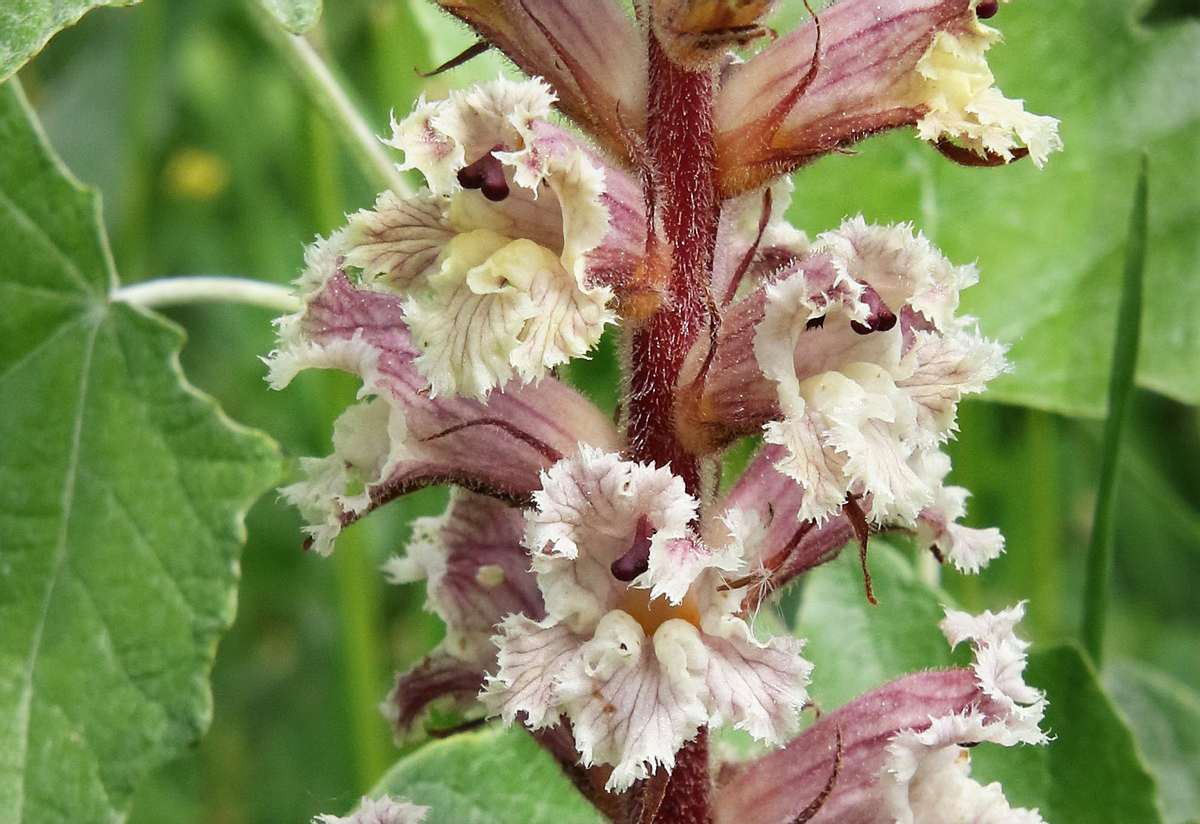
0, 83, 278, 824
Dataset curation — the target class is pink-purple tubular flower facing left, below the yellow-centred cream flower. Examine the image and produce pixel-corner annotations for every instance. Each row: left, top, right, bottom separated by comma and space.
269, 244, 617, 553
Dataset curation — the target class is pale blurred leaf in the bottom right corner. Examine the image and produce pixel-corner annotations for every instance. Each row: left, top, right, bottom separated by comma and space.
1104, 661, 1200, 824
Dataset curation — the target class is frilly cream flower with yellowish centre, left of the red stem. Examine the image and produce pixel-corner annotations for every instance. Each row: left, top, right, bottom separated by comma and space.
344, 78, 616, 399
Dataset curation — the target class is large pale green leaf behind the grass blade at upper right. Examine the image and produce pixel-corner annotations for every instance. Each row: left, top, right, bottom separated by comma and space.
792, 0, 1200, 417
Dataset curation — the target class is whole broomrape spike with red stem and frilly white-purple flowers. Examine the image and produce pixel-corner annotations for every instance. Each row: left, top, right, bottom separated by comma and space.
269, 0, 1060, 824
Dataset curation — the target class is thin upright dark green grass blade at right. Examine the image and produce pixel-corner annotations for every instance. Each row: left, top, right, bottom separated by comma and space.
1082, 156, 1148, 667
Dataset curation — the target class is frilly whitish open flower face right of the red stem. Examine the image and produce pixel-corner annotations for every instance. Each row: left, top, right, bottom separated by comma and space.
754, 217, 1004, 525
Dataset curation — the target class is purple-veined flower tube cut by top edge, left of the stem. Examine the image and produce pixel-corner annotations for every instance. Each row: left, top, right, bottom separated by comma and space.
436, 0, 647, 163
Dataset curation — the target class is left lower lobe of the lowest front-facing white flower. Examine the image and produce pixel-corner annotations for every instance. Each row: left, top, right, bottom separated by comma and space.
480, 615, 583, 729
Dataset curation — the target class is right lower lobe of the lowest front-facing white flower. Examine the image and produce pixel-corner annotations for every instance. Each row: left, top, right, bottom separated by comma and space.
700, 615, 812, 745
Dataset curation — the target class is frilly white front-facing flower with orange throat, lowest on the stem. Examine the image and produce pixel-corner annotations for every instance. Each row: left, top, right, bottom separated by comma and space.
482, 446, 811, 790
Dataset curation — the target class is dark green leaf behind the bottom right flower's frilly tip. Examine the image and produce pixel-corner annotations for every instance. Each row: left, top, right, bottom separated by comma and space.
971, 645, 1163, 824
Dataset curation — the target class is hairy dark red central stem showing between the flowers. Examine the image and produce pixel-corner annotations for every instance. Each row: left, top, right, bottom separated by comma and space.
625, 35, 720, 824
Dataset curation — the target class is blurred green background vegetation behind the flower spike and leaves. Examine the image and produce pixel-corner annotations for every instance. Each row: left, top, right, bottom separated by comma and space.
20, 0, 1200, 824
